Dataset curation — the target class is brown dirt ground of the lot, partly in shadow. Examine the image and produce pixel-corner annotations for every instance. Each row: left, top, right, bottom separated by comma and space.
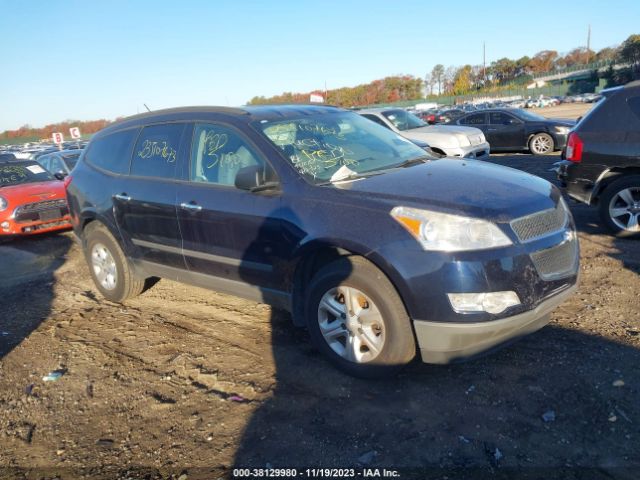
0, 107, 640, 479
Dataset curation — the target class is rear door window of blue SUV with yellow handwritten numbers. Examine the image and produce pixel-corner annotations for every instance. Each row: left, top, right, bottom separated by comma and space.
131, 123, 185, 178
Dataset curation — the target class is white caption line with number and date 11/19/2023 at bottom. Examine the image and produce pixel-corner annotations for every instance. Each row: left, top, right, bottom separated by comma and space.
232, 468, 400, 480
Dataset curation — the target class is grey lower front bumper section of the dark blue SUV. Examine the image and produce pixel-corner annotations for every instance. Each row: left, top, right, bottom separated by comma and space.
413, 283, 578, 364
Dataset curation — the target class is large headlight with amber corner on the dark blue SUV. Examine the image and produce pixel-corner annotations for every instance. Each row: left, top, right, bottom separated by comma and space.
391, 207, 512, 252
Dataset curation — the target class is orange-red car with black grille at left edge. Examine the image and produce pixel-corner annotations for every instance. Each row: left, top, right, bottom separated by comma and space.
0, 160, 71, 238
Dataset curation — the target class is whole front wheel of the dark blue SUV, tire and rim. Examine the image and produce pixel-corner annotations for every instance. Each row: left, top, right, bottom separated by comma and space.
305, 256, 416, 378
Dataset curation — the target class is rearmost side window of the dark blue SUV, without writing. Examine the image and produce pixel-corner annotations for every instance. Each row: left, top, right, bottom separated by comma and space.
84, 128, 138, 174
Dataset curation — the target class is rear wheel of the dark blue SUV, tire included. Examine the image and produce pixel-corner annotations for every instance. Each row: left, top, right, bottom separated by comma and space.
84, 222, 145, 303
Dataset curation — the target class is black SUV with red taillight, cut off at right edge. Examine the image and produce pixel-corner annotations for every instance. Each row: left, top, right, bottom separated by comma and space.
557, 81, 640, 236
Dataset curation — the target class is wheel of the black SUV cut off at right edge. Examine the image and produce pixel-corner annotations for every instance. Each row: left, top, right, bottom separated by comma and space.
598, 175, 640, 237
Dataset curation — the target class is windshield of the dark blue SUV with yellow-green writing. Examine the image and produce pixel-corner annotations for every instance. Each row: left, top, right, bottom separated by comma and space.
254, 111, 432, 184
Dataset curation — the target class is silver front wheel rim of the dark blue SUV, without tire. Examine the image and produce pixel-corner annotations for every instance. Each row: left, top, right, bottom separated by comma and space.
318, 286, 385, 363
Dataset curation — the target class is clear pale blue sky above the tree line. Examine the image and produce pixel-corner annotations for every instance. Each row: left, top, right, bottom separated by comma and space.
0, 0, 640, 131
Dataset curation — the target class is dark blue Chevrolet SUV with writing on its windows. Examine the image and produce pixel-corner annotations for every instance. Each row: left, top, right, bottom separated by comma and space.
67, 105, 579, 376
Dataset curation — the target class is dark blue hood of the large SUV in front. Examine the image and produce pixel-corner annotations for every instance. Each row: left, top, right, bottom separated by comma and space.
335, 158, 560, 222
